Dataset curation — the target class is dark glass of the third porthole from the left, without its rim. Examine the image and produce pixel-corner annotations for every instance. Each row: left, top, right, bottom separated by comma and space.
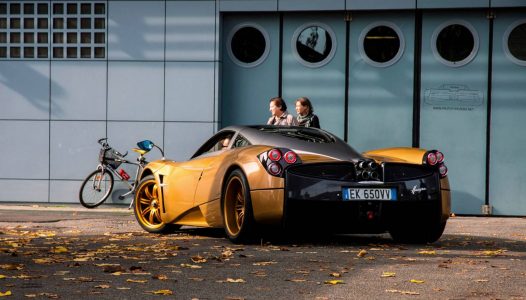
363, 26, 400, 63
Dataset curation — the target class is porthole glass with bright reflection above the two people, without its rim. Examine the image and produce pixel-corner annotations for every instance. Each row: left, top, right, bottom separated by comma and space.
296, 26, 332, 63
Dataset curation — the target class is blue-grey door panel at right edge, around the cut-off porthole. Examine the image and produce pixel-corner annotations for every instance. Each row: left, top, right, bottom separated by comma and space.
489, 12, 526, 216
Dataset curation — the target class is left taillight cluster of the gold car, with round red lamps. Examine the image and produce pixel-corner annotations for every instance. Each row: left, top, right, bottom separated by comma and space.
258, 148, 301, 177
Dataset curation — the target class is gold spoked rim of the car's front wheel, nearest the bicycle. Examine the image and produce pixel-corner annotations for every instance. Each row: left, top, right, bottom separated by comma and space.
135, 179, 165, 230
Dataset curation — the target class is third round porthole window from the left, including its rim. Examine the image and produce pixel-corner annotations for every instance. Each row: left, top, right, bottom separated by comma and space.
360, 22, 405, 67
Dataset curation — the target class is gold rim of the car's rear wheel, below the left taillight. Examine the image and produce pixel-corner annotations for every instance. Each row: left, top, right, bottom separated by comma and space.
223, 176, 246, 236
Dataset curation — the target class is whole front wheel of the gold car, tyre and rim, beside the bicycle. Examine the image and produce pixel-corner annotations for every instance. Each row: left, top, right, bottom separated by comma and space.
133, 175, 181, 233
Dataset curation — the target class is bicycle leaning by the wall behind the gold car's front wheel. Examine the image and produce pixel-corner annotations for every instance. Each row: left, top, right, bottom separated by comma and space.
79, 138, 164, 208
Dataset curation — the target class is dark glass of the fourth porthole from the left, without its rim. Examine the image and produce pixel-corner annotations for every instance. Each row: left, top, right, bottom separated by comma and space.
436, 24, 475, 62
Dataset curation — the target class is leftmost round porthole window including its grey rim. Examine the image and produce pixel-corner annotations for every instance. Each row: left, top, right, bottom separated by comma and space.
227, 23, 270, 68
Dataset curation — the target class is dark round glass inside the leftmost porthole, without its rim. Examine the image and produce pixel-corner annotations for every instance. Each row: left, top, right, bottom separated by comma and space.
231, 27, 267, 64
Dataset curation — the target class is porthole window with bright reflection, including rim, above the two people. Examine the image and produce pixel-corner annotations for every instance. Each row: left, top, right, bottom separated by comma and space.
292, 23, 336, 68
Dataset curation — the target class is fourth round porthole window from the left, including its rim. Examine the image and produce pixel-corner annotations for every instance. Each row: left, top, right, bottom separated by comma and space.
431, 20, 479, 67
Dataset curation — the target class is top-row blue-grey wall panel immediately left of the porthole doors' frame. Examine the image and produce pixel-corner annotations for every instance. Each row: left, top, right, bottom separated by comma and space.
166, 1, 216, 61
